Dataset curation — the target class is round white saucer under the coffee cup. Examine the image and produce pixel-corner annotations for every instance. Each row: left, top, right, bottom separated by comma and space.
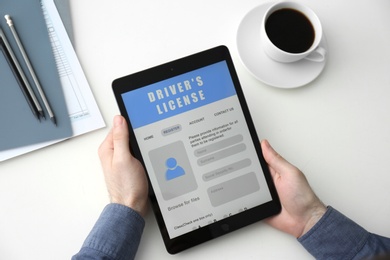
237, 3, 329, 88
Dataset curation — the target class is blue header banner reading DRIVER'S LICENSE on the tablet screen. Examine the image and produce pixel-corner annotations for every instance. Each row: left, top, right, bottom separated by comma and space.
122, 61, 236, 129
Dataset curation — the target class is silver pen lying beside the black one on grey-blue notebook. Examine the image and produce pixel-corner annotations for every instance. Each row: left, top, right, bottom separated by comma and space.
4, 14, 57, 125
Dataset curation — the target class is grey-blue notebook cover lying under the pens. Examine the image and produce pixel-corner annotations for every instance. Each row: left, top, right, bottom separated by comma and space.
0, 0, 73, 151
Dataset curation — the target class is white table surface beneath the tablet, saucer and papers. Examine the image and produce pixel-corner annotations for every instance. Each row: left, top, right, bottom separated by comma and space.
0, 0, 390, 260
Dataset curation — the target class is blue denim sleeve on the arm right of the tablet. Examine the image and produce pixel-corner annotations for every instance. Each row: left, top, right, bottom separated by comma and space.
298, 207, 390, 259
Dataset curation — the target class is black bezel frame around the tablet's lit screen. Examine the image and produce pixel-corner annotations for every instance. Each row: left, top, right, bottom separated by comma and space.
112, 46, 281, 254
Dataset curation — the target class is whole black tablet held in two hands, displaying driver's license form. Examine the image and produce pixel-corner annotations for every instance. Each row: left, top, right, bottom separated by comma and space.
112, 46, 281, 254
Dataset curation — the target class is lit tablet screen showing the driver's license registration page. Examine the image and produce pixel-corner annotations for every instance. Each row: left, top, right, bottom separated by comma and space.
114, 45, 280, 254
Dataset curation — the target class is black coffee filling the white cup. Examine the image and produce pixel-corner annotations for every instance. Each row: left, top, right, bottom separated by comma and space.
265, 8, 315, 53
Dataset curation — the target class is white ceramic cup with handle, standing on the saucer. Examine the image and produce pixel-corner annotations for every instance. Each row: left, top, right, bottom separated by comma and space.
260, 2, 326, 63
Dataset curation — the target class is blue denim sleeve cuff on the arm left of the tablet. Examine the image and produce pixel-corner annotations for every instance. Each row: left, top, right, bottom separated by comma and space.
72, 203, 145, 260
